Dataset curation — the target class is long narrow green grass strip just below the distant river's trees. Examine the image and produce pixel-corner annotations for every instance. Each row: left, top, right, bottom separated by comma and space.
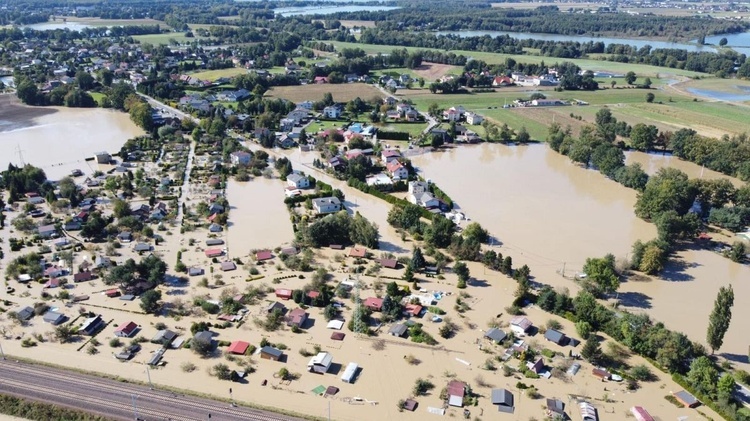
326, 41, 705, 78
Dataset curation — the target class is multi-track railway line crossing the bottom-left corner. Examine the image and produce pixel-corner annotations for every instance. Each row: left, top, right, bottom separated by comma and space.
0, 359, 308, 421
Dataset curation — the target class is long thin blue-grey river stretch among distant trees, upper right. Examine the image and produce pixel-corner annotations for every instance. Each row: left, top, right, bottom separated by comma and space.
435, 31, 716, 52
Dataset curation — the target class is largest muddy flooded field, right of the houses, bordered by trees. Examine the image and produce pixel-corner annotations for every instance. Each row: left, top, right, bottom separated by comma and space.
413, 144, 656, 278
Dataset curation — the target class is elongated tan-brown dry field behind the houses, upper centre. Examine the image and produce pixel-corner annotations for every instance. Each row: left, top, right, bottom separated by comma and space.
266, 83, 383, 103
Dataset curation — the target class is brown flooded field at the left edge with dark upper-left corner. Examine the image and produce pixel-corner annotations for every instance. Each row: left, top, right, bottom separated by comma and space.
0, 96, 144, 179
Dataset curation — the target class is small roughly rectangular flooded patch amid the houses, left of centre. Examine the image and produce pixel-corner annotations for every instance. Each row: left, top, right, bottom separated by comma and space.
227, 177, 294, 256
